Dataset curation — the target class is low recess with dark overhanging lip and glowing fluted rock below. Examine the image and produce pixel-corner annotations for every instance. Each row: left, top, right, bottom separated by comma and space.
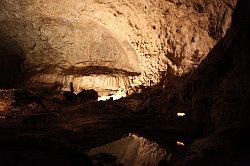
26, 66, 140, 99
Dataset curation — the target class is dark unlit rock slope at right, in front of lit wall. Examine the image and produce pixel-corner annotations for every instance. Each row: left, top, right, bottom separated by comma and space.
150, 1, 250, 134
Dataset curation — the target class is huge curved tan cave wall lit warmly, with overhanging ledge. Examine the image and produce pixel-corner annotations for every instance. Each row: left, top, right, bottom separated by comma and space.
0, 0, 236, 95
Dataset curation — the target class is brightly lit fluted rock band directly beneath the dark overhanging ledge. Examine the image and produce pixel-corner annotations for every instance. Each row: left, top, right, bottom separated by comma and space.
31, 73, 134, 96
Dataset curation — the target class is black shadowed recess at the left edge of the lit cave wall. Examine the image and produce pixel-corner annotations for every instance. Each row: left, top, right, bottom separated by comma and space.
0, 32, 25, 88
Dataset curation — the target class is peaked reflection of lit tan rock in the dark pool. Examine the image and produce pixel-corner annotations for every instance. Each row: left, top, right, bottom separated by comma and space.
89, 134, 167, 166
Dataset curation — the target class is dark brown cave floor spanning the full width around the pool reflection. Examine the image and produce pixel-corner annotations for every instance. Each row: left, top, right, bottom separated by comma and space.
0, 90, 247, 166
